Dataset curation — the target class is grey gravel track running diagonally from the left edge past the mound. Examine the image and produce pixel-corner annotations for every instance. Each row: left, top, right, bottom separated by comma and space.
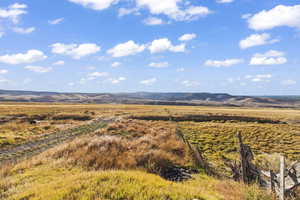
0, 118, 115, 165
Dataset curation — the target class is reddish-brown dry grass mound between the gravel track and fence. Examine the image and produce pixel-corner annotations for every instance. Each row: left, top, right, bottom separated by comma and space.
50, 120, 191, 174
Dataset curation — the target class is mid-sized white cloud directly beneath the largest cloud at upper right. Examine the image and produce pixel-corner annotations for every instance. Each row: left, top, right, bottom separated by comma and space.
240, 33, 279, 49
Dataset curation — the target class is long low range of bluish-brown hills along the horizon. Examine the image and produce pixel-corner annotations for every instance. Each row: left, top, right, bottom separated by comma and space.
0, 90, 300, 107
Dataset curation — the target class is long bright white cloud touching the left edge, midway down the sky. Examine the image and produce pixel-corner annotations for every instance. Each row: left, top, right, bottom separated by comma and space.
0, 49, 47, 65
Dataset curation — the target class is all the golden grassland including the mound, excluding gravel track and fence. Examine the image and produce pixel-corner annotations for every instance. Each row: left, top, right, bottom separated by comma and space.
0, 103, 300, 200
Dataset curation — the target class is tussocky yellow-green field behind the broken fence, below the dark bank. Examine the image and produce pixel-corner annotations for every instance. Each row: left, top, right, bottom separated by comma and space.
180, 122, 300, 170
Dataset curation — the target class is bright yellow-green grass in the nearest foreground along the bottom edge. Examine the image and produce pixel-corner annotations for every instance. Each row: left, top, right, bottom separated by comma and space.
0, 155, 274, 200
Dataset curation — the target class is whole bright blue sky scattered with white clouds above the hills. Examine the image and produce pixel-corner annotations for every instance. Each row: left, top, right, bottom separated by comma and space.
0, 0, 300, 95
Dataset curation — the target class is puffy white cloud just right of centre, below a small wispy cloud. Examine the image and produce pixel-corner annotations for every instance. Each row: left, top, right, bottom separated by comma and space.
149, 38, 185, 53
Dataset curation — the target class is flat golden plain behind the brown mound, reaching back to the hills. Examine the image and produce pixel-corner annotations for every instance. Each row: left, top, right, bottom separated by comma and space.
0, 103, 300, 164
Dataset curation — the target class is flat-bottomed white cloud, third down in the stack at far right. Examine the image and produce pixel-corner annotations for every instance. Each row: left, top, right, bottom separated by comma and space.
250, 50, 287, 65
